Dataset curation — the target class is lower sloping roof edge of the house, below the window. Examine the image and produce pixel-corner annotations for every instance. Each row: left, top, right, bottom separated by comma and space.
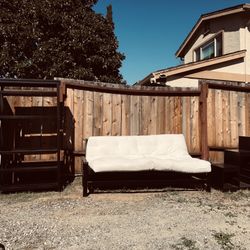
138, 50, 246, 85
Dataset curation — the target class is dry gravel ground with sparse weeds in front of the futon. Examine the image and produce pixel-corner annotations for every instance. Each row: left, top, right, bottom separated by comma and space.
0, 179, 250, 250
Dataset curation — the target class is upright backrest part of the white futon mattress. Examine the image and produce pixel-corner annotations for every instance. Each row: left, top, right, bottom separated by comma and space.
86, 134, 188, 159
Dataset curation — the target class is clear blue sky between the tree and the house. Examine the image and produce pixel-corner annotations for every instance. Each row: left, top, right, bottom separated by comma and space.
94, 0, 246, 84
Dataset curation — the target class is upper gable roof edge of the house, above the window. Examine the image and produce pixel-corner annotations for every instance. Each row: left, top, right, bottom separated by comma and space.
175, 3, 250, 57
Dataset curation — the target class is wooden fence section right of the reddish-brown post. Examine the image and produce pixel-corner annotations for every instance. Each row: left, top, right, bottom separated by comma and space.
207, 82, 250, 162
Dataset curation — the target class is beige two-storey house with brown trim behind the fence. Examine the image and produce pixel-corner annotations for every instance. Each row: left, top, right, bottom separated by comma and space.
138, 4, 250, 87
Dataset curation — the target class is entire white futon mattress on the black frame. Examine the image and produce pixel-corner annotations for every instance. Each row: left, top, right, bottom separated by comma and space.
86, 134, 211, 173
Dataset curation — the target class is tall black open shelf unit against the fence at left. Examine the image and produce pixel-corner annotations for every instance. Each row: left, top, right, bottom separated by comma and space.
0, 79, 71, 192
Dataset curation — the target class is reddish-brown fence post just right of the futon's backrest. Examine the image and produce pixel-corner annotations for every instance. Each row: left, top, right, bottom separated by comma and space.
199, 83, 209, 160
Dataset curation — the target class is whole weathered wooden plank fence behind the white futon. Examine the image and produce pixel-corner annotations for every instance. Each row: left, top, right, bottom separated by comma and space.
3, 79, 250, 172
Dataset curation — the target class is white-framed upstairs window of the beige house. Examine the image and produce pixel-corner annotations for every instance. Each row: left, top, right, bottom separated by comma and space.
194, 34, 222, 61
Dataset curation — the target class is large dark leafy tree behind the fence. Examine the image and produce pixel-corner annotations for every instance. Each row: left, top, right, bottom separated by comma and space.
0, 0, 125, 83
